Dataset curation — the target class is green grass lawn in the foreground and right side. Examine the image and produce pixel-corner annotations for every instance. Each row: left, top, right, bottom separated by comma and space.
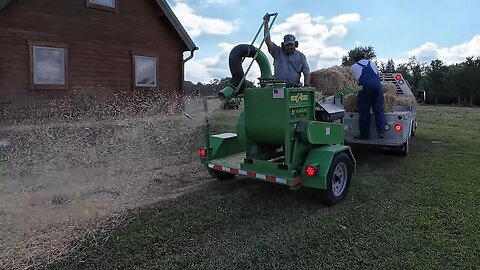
43, 106, 480, 269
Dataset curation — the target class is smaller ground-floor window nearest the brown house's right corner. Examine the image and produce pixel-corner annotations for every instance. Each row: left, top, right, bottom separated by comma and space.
133, 55, 157, 87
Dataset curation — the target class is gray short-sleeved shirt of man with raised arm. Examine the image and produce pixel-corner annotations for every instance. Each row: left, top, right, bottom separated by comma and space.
270, 44, 310, 85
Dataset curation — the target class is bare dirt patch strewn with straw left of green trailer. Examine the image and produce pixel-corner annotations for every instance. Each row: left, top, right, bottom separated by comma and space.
0, 96, 239, 269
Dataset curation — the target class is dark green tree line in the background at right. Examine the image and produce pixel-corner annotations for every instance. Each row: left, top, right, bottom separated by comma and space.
342, 46, 480, 106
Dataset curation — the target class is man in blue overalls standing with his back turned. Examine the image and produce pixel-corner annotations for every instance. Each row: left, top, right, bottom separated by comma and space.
352, 53, 385, 140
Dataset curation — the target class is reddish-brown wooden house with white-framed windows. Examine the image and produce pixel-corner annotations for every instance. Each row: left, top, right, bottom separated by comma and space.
0, 0, 198, 114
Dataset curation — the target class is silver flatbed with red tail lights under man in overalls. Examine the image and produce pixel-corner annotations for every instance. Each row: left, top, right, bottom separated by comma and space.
343, 73, 425, 156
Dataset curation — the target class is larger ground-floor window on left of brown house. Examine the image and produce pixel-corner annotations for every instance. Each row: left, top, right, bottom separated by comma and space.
32, 46, 66, 87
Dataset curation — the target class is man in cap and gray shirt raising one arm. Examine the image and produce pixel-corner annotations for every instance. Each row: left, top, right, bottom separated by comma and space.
263, 14, 310, 87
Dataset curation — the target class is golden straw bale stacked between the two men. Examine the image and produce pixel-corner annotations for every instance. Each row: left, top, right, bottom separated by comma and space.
310, 66, 357, 96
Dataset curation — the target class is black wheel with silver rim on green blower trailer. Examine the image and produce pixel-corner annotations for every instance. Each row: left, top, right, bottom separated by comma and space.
322, 152, 352, 205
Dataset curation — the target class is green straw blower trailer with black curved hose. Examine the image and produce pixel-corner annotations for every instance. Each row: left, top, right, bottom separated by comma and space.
199, 10, 361, 205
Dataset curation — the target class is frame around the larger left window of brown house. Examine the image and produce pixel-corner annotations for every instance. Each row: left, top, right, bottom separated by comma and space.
31, 45, 67, 88
